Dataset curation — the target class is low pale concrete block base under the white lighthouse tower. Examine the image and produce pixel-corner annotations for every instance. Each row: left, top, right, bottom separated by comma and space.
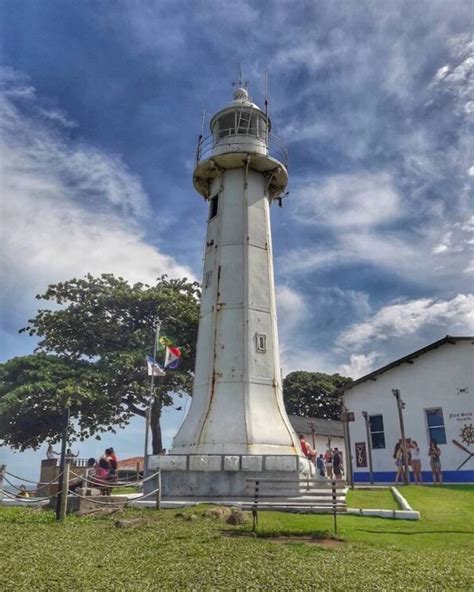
145, 455, 314, 499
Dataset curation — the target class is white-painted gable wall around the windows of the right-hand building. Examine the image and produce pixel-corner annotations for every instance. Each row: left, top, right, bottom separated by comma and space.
345, 340, 474, 481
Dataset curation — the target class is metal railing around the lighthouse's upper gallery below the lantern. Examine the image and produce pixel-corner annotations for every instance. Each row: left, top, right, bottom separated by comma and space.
196, 127, 288, 168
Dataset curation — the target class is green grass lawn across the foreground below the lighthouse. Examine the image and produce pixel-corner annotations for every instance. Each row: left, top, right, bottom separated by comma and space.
0, 486, 474, 592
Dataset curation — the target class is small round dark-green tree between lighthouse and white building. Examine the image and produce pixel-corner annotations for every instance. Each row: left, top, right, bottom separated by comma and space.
283, 370, 352, 419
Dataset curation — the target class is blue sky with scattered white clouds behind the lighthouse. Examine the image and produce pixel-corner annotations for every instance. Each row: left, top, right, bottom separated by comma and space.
0, 0, 474, 475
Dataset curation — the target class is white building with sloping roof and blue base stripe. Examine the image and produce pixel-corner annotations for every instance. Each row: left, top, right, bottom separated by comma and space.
344, 335, 474, 483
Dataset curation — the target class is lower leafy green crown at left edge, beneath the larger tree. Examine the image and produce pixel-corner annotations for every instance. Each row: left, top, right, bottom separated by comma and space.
0, 354, 114, 450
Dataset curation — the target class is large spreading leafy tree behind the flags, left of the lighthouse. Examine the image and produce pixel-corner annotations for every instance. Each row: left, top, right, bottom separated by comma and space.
0, 274, 200, 453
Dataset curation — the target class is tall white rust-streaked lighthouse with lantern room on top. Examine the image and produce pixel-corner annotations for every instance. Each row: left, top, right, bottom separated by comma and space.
150, 88, 309, 495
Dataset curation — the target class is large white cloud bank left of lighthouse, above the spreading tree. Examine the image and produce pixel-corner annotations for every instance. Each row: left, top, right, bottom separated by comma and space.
0, 71, 192, 330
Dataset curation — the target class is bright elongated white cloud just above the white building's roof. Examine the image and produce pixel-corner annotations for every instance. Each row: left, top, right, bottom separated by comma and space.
336, 294, 474, 349
